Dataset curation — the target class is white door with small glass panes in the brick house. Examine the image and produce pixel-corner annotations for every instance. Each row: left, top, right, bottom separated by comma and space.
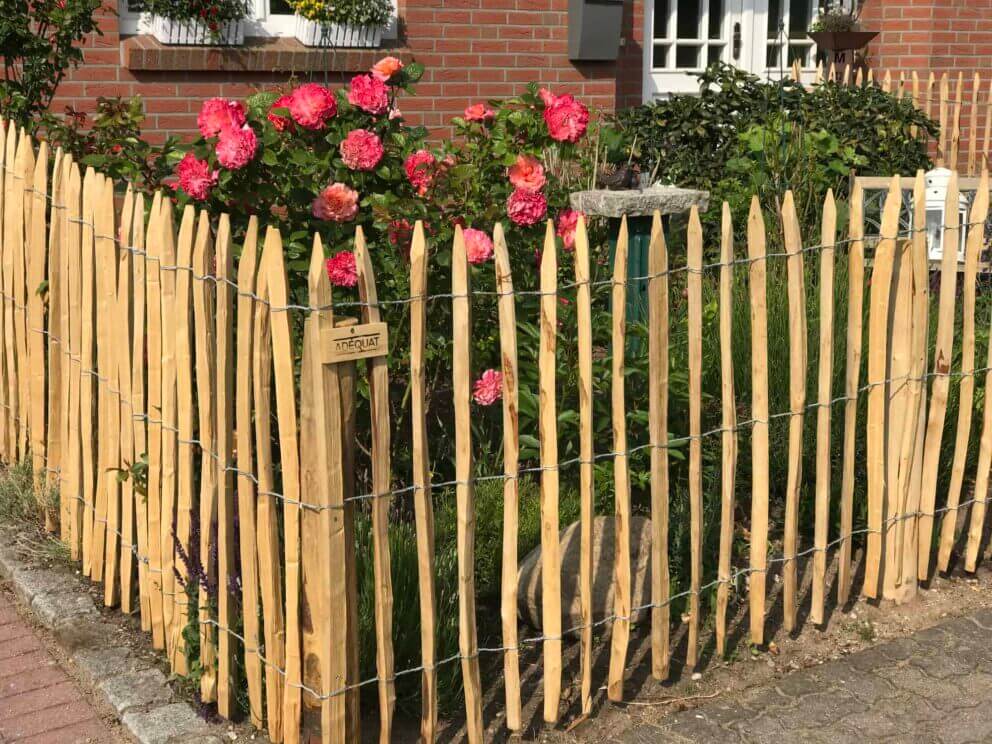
644, 0, 819, 101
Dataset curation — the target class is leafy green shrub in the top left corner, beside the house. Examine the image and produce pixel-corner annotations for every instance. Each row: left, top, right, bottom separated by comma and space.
0, 0, 100, 124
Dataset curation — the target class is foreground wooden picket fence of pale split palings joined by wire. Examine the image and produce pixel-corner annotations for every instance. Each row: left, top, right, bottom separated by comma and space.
0, 110, 992, 742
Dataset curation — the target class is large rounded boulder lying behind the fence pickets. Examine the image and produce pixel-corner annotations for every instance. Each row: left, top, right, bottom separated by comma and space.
517, 517, 651, 632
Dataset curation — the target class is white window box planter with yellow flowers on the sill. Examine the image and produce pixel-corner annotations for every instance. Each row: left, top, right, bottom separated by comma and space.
293, 0, 393, 47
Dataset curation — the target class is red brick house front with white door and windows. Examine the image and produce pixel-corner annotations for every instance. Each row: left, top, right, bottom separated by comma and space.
56, 0, 992, 144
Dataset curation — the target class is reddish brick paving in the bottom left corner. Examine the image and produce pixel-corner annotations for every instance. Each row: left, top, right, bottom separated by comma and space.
0, 592, 119, 744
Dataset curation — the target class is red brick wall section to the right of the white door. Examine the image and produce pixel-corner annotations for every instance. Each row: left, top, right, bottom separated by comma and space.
861, 0, 992, 167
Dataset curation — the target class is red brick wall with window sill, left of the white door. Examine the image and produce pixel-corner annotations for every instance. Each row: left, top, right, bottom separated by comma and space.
55, 0, 643, 141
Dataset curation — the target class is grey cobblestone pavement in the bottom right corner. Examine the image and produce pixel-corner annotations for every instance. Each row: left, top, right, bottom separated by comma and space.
619, 610, 992, 744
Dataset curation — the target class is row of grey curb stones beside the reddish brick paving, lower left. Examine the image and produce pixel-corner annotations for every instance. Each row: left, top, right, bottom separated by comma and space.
0, 527, 248, 744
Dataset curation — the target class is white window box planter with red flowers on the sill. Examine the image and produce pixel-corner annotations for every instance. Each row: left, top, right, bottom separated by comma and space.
146, 0, 250, 46
